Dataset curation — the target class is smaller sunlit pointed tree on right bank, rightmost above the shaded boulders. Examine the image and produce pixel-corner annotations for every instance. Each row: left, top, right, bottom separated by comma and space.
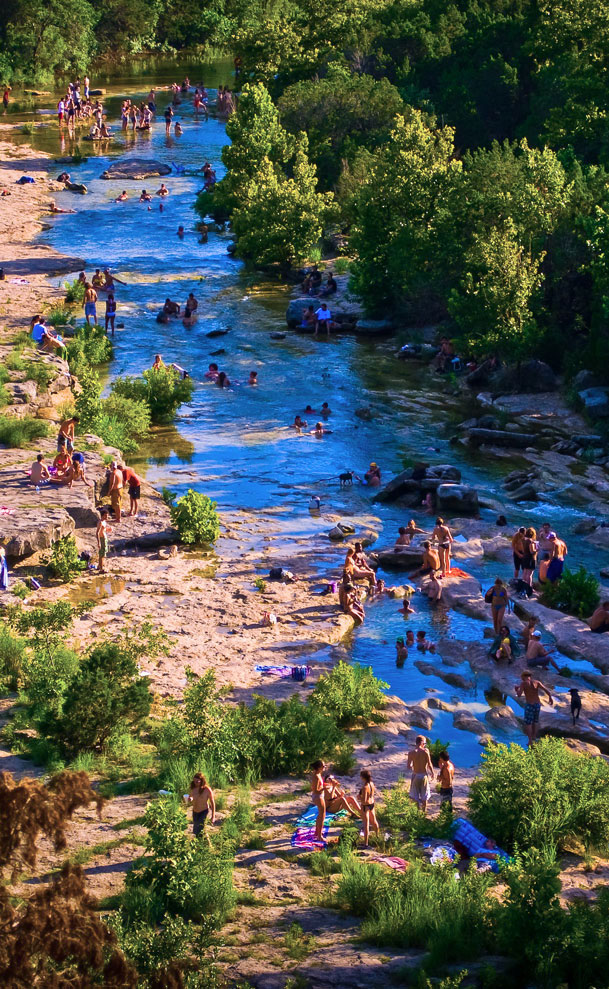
448, 221, 545, 360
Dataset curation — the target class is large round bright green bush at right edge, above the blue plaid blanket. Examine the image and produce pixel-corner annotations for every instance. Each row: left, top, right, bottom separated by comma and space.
469, 738, 609, 850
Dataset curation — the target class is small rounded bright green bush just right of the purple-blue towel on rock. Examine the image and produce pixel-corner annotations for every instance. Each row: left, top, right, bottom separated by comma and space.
311, 660, 389, 726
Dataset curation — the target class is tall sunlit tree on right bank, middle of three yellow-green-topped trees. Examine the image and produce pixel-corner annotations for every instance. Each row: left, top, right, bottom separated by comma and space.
351, 108, 461, 312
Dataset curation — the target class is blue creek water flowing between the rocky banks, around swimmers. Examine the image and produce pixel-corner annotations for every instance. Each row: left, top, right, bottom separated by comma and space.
13, 62, 599, 765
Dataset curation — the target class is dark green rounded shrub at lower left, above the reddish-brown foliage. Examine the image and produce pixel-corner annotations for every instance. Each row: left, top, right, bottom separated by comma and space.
49, 642, 152, 755
